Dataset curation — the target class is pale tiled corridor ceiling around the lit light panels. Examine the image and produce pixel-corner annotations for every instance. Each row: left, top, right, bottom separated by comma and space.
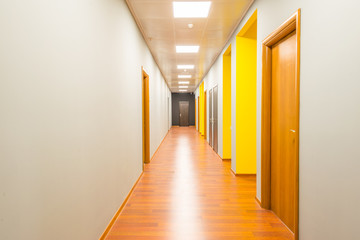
126, 0, 254, 92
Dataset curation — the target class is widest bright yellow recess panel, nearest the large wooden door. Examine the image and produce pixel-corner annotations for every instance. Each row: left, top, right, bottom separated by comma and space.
236, 11, 257, 174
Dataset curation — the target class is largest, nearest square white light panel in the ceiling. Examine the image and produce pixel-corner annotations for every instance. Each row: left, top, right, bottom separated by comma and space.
173, 2, 211, 18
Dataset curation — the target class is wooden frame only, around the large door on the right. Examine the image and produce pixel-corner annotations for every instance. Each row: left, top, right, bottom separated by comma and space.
261, 9, 300, 240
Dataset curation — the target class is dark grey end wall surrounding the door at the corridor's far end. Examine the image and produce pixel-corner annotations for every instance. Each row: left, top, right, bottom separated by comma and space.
171, 93, 195, 126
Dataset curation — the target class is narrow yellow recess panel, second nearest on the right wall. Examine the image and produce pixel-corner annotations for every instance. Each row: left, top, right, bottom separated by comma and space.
223, 45, 231, 159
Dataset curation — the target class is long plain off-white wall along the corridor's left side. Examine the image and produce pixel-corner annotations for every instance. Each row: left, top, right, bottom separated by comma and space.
0, 0, 171, 240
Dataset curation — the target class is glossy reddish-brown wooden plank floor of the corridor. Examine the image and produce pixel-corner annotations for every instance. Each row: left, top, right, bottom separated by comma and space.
106, 127, 293, 240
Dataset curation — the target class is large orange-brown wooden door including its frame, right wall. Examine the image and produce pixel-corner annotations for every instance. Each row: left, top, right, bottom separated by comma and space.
261, 9, 300, 240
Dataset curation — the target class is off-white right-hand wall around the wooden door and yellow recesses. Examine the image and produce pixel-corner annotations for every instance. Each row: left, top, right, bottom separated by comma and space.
197, 0, 360, 240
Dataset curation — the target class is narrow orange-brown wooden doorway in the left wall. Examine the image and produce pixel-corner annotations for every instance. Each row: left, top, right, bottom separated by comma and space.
141, 67, 150, 167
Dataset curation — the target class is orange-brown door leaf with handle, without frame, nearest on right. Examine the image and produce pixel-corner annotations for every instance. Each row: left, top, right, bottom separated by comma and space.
270, 32, 299, 232
